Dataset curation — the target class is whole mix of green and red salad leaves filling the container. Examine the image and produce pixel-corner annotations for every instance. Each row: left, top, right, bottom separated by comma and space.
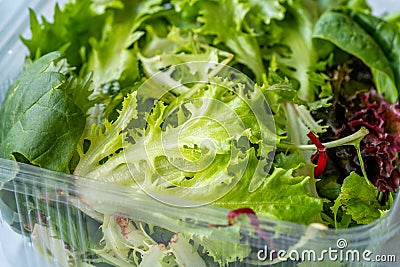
0, 0, 400, 266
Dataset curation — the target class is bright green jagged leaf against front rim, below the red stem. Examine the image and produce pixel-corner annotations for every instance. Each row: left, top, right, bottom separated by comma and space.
214, 162, 322, 224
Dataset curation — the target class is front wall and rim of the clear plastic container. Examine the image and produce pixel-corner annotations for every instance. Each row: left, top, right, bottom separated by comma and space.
0, 156, 400, 266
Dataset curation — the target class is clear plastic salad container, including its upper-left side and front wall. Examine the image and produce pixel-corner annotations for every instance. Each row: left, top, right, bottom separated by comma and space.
0, 1, 400, 267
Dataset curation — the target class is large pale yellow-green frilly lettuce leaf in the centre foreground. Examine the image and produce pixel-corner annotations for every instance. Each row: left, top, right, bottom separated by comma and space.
75, 65, 276, 205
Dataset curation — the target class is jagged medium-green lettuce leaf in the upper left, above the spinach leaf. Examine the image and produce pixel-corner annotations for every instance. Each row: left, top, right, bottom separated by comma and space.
22, 0, 106, 70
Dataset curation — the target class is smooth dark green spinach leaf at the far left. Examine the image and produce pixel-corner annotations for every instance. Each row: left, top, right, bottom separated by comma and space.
0, 52, 85, 171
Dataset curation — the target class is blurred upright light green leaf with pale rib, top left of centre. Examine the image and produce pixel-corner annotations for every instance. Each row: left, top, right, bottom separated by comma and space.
86, 1, 144, 98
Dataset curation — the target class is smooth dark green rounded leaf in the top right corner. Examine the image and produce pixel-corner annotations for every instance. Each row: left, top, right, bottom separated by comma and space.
313, 12, 399, 102
